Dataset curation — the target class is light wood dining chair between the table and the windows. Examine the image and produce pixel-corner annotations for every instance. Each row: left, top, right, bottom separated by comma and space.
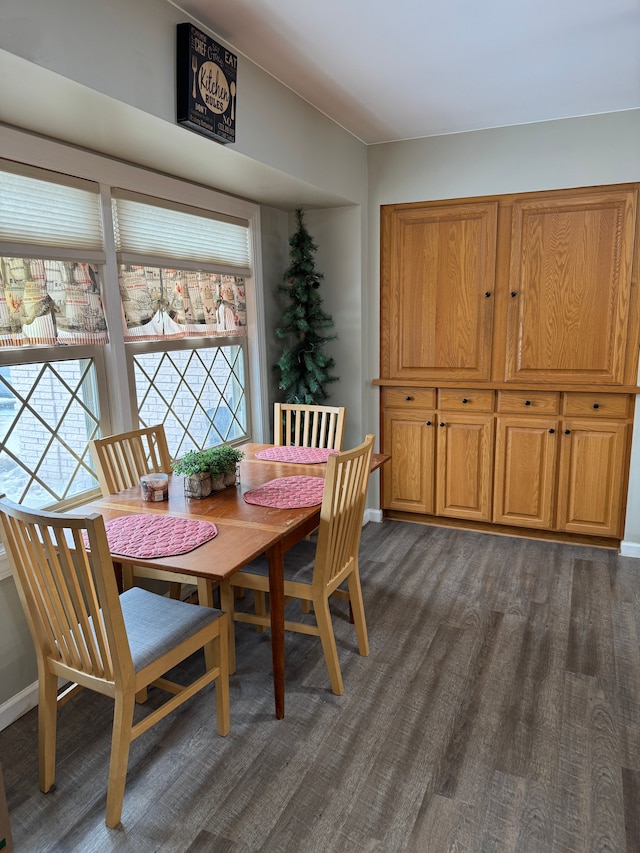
89, 424, 193, 598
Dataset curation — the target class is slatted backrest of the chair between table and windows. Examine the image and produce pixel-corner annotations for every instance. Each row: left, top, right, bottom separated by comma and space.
89, 424, 171, 495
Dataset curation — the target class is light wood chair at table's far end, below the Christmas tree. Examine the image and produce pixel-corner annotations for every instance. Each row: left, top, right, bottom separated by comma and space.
273, 403, 347, 450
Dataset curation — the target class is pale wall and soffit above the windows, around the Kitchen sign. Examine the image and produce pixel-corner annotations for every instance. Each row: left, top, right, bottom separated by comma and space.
0, 0, 366, 210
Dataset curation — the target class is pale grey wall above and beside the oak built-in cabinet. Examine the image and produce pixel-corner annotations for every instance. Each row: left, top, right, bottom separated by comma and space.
364, 110, 640, 550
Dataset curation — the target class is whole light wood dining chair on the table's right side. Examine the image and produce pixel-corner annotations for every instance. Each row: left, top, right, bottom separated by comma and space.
220, 435, 374, 695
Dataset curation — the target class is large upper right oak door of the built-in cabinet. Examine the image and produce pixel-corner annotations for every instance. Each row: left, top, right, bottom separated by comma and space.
505, 190, 635, 384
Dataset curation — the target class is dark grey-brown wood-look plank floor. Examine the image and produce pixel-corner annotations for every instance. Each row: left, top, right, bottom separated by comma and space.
0, 521, 640, 853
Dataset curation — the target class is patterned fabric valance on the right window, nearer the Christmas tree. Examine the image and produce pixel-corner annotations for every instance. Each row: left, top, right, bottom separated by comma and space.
119, 264, 247, 341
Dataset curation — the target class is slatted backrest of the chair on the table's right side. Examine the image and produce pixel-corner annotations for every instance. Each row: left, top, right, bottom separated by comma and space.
313, 435, 374, 586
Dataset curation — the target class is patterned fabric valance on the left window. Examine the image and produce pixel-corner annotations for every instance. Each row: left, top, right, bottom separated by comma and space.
0, 258, 109, 347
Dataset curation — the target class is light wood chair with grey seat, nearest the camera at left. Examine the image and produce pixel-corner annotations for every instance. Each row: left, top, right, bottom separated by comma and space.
0, 500, 229, 827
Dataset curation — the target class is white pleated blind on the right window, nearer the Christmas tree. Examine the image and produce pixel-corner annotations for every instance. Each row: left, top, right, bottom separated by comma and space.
113, 190, 251, 276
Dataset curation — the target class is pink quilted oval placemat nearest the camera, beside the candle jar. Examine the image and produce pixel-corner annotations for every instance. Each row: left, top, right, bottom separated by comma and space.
86, 515, 218, 560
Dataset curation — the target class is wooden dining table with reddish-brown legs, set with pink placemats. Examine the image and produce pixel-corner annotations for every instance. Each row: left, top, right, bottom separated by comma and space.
80, 443, 388, 719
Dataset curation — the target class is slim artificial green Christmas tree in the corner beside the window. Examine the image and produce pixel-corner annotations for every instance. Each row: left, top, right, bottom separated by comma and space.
275, 209, 338, 405
